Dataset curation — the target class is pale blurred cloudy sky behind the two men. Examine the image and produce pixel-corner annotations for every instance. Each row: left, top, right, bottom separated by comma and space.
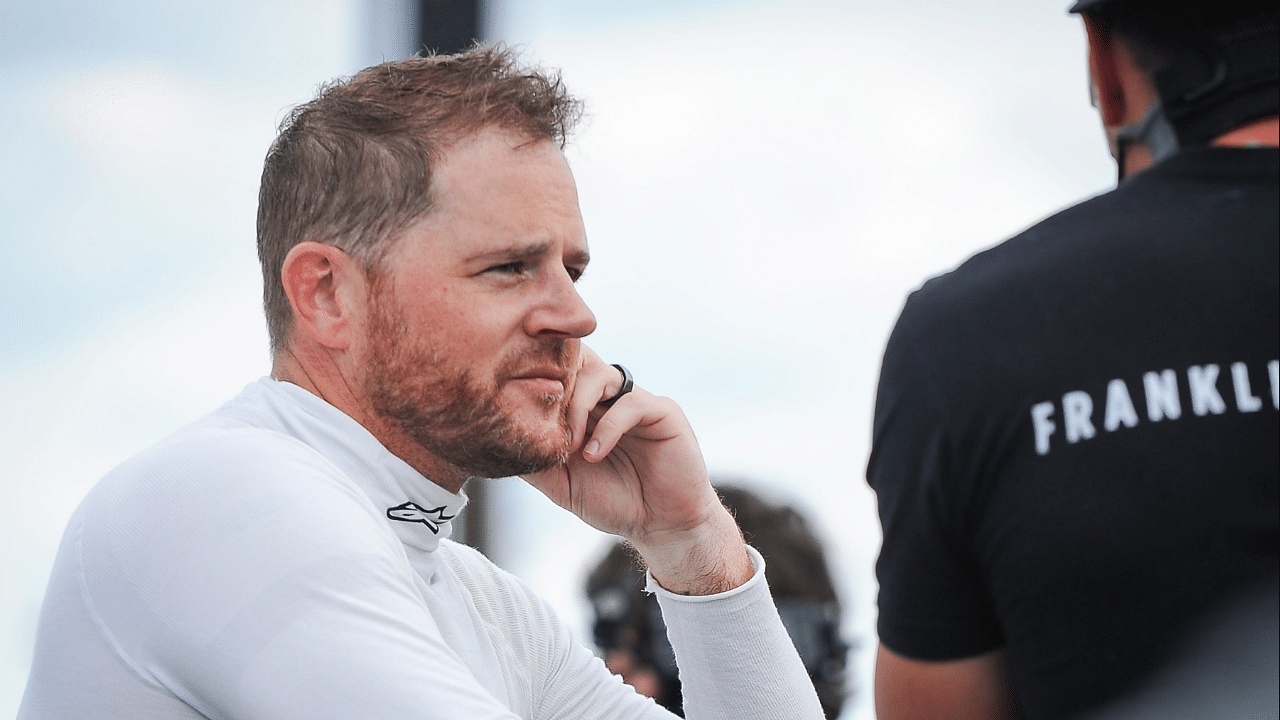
0, 0, 1115, 720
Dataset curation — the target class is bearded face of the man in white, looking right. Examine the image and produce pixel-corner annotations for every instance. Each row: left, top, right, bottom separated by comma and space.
362, 131, 595, 479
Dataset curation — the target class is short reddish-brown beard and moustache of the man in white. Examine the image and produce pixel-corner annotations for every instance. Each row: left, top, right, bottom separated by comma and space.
362, 287, 572, 478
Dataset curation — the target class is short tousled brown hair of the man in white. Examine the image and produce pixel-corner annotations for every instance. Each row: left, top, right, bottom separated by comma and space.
257, 45, 582, 354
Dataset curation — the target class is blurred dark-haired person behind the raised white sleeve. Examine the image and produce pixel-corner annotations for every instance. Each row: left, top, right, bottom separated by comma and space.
586, 480, 849, 719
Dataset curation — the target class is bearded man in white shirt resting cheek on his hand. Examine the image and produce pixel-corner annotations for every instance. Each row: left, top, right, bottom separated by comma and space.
19, 49, 822, 720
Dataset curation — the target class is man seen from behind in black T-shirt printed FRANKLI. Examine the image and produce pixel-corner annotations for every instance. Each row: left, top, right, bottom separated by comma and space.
868, 0, 1280, 720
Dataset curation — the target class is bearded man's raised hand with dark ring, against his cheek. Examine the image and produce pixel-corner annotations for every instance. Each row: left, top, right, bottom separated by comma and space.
525, 346, 753, 594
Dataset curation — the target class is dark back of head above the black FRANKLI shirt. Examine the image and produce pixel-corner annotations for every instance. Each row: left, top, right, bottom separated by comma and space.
1071, 0, 1280, 147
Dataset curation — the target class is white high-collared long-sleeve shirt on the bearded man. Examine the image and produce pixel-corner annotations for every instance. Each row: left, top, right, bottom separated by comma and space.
18, 378, 822, 720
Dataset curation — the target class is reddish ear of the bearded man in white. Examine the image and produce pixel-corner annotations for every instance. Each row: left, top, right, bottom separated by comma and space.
280, 242, 367, 350
